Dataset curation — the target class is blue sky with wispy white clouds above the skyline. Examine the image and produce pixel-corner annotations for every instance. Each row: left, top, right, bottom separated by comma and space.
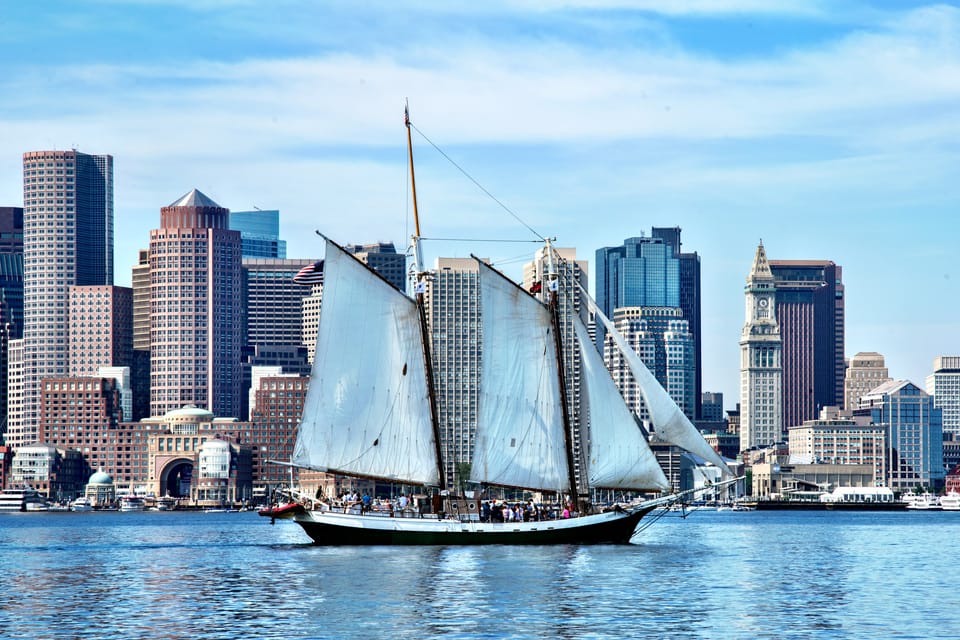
0, 0, 960, 408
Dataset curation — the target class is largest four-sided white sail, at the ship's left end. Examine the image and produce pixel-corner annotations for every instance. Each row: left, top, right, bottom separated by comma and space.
293, 240, 439, 484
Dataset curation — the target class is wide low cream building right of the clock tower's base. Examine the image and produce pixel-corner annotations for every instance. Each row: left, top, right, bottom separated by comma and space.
787, 407, 887, 485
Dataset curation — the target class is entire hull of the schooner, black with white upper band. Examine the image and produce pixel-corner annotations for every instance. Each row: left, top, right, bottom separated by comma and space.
293, 506, 655, 545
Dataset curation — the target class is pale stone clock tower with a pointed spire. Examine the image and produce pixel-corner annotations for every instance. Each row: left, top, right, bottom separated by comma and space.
739, 243, 785, 451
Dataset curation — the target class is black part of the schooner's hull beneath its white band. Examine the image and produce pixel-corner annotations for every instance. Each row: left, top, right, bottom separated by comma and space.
294, 507, 655, 546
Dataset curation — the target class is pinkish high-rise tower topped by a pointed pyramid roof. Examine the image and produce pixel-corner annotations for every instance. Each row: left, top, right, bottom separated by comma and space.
150, 189, 243, 418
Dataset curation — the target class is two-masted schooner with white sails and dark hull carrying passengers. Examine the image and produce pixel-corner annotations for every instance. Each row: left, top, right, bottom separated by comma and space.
291, 110, 730, 545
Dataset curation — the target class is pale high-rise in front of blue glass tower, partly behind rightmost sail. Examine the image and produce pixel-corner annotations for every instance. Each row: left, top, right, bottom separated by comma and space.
604, 307, 696, 421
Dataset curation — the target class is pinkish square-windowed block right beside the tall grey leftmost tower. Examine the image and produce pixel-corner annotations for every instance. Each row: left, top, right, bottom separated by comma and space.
68, 285, 133, 378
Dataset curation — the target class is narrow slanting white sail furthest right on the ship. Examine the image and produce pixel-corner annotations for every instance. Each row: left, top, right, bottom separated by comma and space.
581, 289, 733, 477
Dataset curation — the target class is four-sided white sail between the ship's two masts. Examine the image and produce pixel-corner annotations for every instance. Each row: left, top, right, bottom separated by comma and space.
471, 261, 570, 491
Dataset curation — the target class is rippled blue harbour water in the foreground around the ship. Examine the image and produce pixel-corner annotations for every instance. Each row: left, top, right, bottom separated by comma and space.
0, 512, 960, 640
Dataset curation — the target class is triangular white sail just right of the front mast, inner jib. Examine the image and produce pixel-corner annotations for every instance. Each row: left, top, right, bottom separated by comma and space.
574, 316, 670, 491
